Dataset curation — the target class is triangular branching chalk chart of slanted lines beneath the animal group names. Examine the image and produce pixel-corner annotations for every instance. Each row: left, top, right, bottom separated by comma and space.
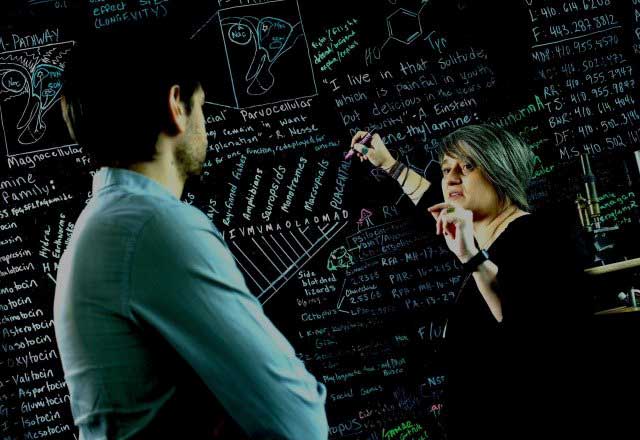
227, 222, 348, 304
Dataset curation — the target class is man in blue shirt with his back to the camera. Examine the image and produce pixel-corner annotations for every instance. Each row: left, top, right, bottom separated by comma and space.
54, 38, 327, 440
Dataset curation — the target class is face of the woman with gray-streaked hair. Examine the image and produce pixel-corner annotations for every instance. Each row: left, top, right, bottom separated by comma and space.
440, 141, 500, 221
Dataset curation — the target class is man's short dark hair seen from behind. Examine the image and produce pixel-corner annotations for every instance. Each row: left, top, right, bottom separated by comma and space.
62, 35, 201, 167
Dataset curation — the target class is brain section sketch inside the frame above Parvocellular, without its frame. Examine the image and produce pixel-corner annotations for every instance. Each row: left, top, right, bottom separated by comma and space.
221, 17, 303, 95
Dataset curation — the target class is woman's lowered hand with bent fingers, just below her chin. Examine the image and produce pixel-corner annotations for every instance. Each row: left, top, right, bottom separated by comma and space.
429, 203, 478, 263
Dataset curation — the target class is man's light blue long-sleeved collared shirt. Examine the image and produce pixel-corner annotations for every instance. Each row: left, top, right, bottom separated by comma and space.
54, 167, 327, 440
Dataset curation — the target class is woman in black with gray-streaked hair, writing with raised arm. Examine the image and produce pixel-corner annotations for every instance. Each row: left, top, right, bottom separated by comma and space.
351, 124, 590, 440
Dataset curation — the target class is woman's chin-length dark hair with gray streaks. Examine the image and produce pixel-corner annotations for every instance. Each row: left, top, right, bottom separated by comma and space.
440, 124, 534, 210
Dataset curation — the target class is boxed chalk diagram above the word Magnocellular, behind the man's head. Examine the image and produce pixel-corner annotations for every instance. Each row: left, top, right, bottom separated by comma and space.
0, 42, 73, 156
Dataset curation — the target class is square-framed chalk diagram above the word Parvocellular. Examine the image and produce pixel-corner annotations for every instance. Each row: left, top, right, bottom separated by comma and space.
191, 0, 317, 108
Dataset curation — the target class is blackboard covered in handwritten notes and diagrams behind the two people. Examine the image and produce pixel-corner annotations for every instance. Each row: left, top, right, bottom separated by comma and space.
0, 0, 640, 440
